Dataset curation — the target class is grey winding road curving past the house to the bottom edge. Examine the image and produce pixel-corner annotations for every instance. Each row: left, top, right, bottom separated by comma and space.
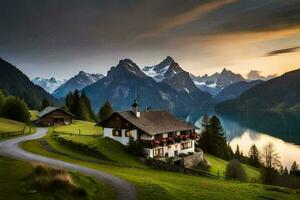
0, 128, 137, 200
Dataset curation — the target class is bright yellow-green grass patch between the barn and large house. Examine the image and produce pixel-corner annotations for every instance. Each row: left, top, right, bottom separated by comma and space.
54, 120, 102, 135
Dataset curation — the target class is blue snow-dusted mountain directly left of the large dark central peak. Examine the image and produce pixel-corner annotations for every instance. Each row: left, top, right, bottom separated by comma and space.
52, 71, 104, 98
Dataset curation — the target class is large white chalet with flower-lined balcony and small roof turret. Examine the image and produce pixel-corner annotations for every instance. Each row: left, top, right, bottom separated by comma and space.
98, 100, 197, 158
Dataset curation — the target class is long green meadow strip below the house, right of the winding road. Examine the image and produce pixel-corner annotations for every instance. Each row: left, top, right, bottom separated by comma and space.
23, 133, 300, 200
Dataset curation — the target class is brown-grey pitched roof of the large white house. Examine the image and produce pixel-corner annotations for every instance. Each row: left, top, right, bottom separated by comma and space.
98, 111, 198, 135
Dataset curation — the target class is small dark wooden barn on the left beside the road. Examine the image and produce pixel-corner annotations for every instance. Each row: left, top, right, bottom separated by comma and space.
36, 106, 74, 126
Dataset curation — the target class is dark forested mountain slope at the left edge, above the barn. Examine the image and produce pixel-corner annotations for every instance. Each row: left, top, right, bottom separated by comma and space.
0, 58, 58, 108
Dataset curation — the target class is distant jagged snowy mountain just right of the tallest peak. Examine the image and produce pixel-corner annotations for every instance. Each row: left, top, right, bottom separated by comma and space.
191, 68, 245, 96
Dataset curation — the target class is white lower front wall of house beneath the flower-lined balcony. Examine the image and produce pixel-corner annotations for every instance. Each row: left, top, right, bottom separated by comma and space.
145, 140, 195, 158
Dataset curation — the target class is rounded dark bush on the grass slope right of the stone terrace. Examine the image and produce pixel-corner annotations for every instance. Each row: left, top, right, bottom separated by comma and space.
226, 159, 247, 182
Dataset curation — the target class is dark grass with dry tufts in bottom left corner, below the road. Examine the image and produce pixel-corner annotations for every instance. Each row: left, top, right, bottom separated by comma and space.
0, 157, 114, 200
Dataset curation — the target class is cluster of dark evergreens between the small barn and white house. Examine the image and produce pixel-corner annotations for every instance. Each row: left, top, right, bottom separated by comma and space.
65, 90, 113, 121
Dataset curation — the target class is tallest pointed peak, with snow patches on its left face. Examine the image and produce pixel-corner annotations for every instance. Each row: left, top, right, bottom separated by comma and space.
142, 56, 211, 101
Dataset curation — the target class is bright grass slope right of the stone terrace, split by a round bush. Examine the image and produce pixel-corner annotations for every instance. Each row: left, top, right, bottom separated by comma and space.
204, 154, 260, 182
